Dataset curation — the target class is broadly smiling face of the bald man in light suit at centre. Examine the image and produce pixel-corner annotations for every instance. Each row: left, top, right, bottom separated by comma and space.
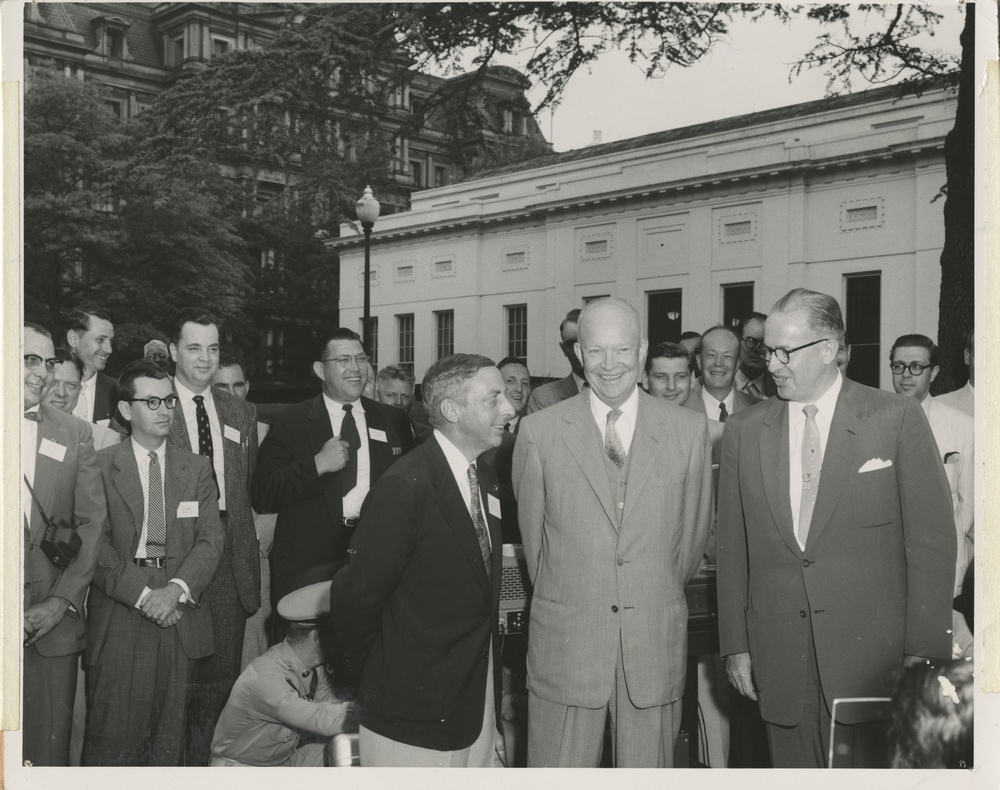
576, 302, 647, 409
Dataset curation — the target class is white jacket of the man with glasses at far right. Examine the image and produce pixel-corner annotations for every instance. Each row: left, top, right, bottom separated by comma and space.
922, 395, 976, 597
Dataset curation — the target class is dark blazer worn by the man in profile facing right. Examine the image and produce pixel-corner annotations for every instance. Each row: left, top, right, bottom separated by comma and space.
331, 438, 503, 751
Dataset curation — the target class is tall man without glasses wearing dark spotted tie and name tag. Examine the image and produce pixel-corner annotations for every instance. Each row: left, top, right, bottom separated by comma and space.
168, 307, 260, 765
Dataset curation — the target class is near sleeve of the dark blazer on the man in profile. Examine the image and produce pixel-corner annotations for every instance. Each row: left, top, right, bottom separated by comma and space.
331, 475, 419, 677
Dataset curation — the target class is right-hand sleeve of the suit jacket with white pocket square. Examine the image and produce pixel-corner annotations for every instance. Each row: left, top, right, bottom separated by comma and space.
896, 399, 958, 659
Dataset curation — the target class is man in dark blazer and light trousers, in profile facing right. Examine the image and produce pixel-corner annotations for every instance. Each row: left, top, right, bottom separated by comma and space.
330, 354, 514, 767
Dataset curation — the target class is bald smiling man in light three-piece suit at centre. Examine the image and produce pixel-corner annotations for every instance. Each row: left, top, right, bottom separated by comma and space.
513, 299, 712, 767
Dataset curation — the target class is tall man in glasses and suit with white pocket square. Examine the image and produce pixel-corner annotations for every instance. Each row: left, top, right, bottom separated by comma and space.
717, 288, 955, 768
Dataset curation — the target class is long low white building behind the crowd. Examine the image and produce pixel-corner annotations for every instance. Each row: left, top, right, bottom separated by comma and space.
328, 80, 956, 387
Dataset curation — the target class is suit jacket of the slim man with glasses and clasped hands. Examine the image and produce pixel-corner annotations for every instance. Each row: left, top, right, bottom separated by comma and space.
87, 442, 225, 665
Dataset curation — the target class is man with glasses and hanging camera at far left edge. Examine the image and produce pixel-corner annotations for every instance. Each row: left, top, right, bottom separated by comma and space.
21, 323, 107, 766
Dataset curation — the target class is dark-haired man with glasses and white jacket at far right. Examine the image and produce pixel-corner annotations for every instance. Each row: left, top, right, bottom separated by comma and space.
889, 335, 976, 657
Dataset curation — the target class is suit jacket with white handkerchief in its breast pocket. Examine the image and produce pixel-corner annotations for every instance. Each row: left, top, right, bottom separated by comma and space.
718, 378, 955, 725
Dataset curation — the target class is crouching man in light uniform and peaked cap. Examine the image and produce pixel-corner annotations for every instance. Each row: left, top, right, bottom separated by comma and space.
209, 563, 357, 767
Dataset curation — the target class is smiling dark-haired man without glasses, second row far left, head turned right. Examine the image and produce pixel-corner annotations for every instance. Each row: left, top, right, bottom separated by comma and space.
66, 305, 118, 425
